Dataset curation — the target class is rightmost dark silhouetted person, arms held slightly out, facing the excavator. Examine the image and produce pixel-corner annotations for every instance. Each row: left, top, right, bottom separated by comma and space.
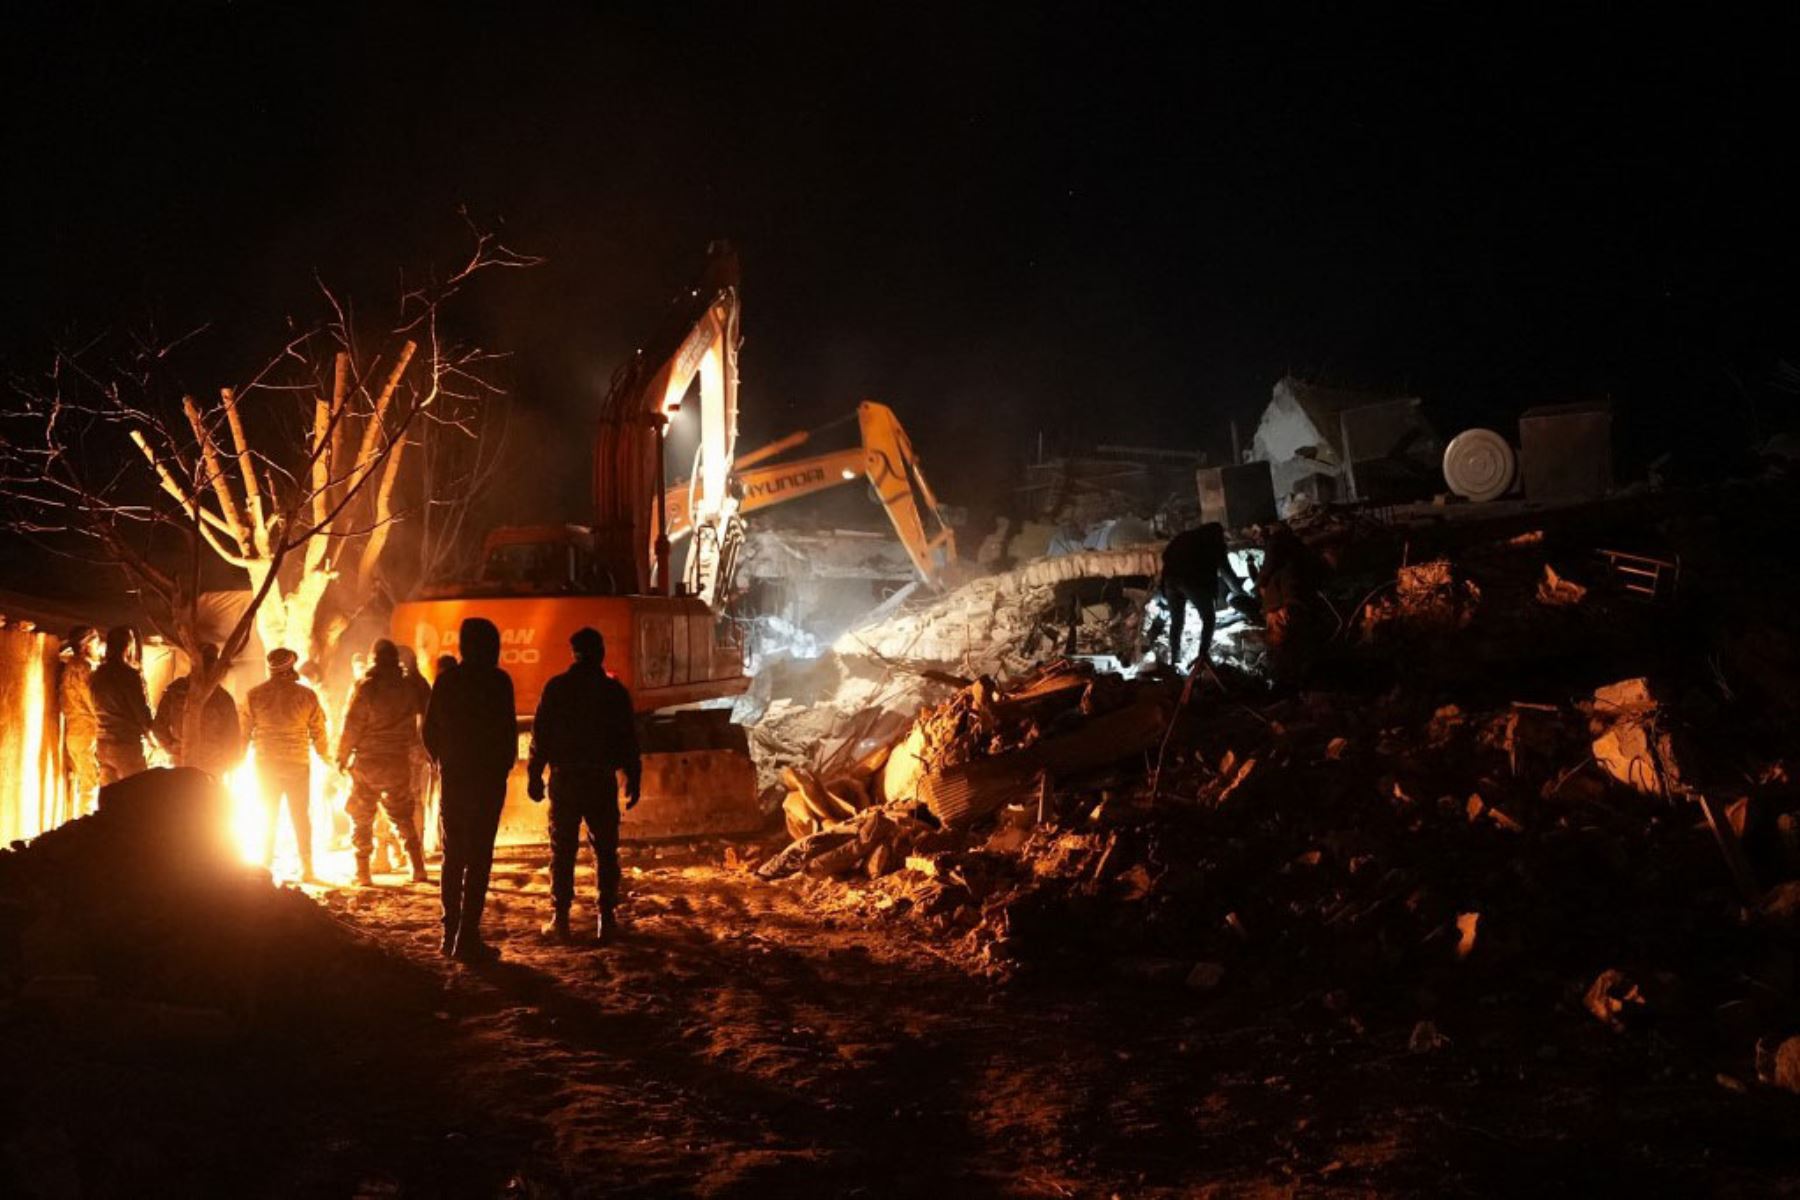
527, 628, 643, 943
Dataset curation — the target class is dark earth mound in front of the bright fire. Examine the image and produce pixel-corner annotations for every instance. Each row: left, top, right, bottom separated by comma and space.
0, 770, 423, 1043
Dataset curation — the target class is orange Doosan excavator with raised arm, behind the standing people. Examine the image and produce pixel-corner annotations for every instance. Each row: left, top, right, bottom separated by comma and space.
392, 243, 761, 844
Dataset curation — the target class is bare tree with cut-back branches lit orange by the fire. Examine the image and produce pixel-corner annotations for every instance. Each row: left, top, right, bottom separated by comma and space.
0, 230, 538, 766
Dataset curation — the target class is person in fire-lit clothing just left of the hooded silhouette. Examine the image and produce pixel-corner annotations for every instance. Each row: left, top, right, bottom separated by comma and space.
337, 637, 430, 887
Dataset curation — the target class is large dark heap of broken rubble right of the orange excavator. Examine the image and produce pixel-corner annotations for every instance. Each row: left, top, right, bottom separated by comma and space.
738, 482, 1800, 1078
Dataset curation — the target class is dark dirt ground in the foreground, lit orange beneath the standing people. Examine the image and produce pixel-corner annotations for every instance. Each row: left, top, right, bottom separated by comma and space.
10, 851, 1800, 1196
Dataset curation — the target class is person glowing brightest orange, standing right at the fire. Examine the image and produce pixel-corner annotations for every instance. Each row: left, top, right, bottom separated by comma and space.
245, 648, 331, 882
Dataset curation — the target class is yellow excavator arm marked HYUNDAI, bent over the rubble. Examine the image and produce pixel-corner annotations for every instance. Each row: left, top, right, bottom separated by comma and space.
662, 399, 956, 588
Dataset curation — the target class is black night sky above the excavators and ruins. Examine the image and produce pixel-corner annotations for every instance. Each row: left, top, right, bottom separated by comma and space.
0, 4, 1800, 516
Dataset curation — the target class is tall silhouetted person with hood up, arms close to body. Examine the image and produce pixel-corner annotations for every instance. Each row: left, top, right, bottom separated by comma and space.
425, 617, 518, 963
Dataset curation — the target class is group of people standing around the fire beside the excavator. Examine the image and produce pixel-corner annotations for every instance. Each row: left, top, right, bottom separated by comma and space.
59, 617, 643, 961
